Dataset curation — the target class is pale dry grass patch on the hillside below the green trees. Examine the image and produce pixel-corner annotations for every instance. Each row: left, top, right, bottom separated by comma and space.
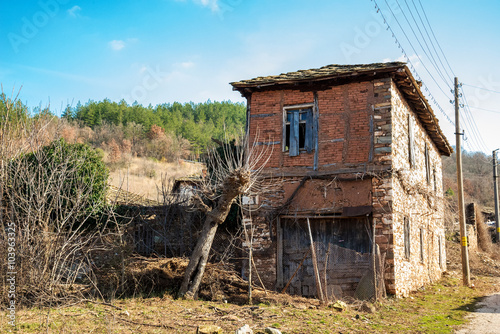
109, 157, 202, 200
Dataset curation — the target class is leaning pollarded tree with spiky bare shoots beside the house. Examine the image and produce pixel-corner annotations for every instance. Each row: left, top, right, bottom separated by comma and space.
179, 132, 272, 299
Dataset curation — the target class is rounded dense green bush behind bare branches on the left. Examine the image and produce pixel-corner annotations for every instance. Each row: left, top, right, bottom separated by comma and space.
8, 139, 108, 223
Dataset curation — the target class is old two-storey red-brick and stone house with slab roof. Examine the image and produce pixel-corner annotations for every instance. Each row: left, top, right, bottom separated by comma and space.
231, 62, 452, 296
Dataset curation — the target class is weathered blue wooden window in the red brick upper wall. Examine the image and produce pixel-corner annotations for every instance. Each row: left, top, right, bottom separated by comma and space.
283, 105, 314, 157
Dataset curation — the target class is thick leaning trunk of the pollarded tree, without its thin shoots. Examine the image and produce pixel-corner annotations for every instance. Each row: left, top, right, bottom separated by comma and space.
179, 169, 250, 299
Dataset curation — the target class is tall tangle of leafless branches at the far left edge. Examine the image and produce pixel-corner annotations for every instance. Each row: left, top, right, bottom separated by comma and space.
0, 90, 110, 304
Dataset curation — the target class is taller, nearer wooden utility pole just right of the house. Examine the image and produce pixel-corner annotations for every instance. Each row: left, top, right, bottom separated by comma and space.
455, 77, 470, 286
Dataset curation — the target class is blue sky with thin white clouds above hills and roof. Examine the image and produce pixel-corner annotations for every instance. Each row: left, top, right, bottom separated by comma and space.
0, 0, 500, 154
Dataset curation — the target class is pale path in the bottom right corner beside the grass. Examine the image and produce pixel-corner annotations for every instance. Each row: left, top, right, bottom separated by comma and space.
456, 293, 500, 334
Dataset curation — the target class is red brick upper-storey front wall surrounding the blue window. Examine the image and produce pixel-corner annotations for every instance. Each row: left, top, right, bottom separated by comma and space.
249, 81, 376, 169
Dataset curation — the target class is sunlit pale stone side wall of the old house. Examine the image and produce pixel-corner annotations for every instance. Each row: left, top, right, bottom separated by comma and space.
391, 84, 446, 296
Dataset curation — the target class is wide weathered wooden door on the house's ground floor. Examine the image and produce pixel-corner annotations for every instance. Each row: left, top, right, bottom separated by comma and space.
278, 217, 371, 297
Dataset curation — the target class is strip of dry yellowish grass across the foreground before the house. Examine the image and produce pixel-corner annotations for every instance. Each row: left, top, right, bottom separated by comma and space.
0, 276, 499, 334
